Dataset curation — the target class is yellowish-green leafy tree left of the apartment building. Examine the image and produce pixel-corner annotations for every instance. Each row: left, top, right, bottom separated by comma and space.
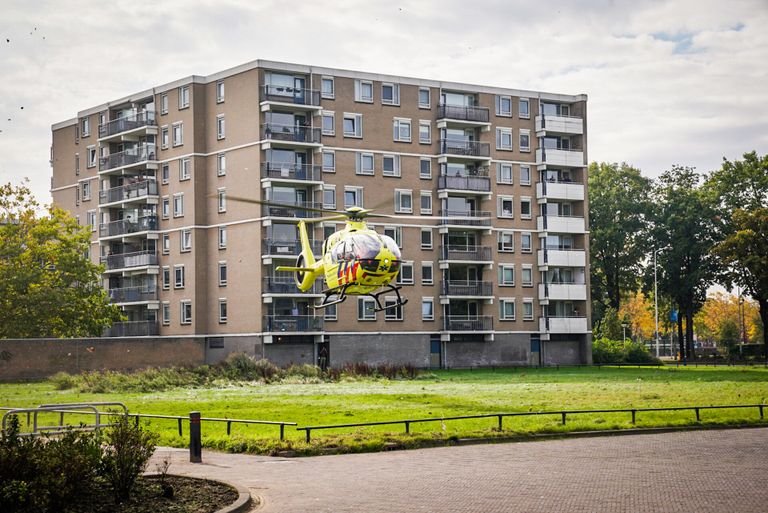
0, 184, 122, 338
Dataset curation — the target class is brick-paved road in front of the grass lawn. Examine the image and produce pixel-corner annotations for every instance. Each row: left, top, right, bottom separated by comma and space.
149, 428, 768, 513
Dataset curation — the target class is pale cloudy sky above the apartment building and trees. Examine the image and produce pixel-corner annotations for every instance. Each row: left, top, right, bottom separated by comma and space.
0, 0, 768, 203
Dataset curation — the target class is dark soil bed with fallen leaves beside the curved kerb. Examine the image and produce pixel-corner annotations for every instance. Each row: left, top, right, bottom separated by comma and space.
71, 476, 238, 513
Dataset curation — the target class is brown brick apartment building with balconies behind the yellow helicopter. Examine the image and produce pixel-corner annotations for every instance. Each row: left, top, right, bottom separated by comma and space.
51, 60, 591, 367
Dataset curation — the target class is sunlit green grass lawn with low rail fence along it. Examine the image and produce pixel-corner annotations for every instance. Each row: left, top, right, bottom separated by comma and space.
0, 367, 768, 453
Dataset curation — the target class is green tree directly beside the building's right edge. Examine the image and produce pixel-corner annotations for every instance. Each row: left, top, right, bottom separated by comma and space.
589, 162, 651, 311
